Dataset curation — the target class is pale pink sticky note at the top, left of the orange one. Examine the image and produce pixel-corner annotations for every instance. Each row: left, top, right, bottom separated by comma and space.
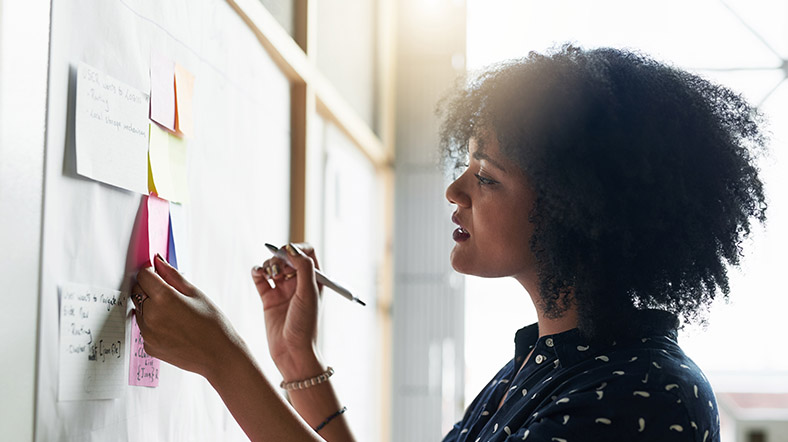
150, 51, 175, 132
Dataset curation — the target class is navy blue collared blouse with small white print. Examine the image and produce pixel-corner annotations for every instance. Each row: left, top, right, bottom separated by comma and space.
444, 310, 720, 442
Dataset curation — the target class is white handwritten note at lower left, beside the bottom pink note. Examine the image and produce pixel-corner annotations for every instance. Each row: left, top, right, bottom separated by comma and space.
58, 283, 126, 401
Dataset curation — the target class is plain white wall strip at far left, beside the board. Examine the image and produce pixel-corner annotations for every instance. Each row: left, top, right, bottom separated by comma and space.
0, 0, 49, 441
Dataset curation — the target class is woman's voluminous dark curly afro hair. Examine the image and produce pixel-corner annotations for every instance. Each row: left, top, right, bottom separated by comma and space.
438, 45, 766, 339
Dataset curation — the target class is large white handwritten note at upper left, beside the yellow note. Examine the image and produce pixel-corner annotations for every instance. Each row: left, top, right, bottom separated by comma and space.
74, 63, 149, 193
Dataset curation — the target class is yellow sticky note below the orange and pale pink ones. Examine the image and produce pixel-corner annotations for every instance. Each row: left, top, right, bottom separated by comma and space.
148, 124, 188, 202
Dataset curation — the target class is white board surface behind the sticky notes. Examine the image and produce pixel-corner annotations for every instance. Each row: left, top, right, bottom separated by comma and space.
36, 0, 290, 441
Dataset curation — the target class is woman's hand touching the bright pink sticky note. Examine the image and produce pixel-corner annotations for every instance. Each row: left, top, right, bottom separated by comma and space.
131, 256, 247, 380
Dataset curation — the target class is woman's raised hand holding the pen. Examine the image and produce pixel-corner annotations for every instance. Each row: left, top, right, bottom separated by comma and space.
252, 244, 325, 382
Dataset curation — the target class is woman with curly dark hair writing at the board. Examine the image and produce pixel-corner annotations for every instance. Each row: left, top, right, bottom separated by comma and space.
134, 46, 766, 441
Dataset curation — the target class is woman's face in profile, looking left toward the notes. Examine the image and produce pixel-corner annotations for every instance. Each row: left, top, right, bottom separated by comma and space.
446, 136, 535, 279
